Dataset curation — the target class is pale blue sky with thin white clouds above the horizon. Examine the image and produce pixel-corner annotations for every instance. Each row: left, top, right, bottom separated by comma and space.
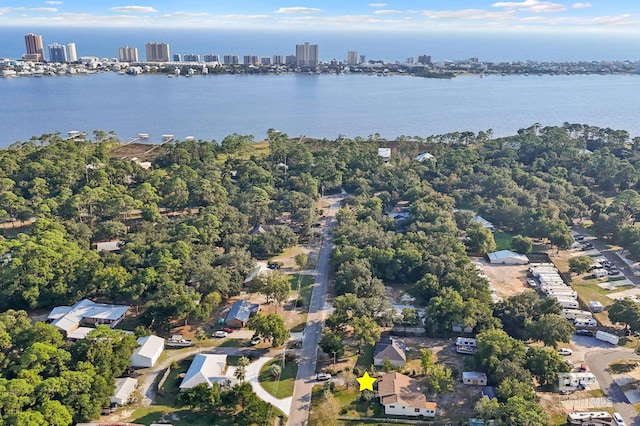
0, 0, 640, 34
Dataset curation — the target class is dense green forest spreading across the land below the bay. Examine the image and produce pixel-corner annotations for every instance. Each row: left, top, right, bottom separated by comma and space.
0, 123, 640, 425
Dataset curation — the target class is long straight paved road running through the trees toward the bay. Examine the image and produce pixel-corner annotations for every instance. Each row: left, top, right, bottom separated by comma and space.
287, 196, 342, 426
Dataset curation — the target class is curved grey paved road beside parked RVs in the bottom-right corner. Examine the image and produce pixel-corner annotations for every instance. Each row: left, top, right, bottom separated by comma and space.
585, 348, 640, 425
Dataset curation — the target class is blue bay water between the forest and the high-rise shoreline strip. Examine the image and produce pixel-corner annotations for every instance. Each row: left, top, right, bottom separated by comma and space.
0, 72, 640, 147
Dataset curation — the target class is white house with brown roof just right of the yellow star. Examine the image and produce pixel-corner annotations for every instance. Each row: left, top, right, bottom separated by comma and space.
377, 372, 438, 417
